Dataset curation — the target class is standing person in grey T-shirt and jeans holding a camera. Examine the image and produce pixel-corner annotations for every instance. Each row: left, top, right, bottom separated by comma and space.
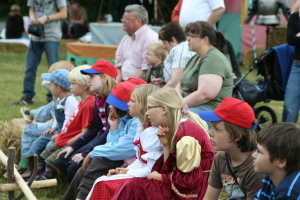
13, 0, 67, 105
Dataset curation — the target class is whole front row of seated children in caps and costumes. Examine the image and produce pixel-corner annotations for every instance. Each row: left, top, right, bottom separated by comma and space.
7, 60, 300, 200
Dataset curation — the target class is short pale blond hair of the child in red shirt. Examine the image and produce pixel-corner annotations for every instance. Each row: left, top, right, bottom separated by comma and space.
68, 65, 91, 88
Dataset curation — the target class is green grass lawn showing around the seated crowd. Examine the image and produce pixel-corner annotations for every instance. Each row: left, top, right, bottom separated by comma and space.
0, 50, 296, 200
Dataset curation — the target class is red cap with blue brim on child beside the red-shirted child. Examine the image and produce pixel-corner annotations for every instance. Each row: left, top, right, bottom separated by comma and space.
80, 60, 118, 78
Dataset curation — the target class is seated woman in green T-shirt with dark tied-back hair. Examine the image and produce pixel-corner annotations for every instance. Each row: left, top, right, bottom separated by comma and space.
176, 21, 233, 118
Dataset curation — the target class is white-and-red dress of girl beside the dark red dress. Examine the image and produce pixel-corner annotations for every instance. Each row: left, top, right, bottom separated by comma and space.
86, 124, 163, 200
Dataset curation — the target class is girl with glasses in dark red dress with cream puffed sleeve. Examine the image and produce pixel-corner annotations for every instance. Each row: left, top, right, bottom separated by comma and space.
112, 87, 214, 200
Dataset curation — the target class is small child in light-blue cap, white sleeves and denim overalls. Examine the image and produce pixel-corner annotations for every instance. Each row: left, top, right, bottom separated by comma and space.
6, 69, 78, 177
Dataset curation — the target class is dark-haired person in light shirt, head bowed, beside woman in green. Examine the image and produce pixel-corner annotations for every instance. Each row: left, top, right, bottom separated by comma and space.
152, 22, 195, 88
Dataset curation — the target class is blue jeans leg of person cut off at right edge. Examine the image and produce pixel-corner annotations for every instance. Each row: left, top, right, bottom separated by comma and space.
282, 62, 300, 123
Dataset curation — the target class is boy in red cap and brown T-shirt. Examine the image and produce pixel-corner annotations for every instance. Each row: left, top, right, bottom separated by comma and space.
198, 98, 262, 200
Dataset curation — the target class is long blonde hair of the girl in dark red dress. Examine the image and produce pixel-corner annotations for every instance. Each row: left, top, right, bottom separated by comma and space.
148, 87, 209, 152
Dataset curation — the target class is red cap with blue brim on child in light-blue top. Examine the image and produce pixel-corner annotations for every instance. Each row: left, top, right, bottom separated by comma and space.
106, 81, 137, 111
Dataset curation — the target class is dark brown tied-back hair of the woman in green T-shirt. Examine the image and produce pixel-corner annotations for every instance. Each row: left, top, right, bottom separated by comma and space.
185, 21, 227, 53
